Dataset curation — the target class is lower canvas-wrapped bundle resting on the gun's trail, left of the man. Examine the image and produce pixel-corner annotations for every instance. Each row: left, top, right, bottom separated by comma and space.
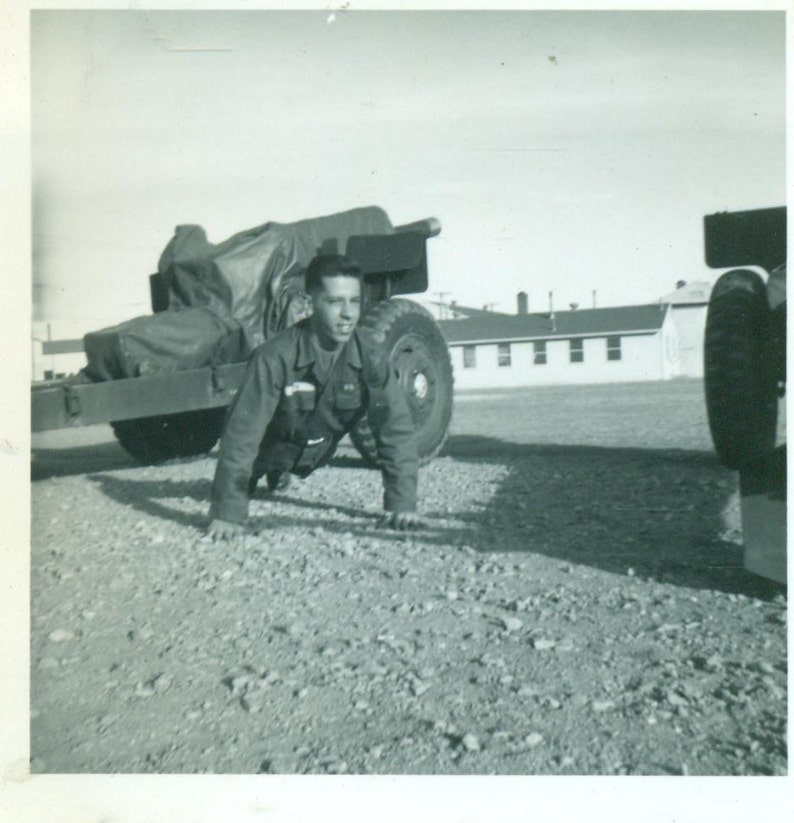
83, 308, 250, 380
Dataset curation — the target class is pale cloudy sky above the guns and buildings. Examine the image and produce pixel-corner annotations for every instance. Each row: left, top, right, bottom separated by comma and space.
31, 11, 786, 336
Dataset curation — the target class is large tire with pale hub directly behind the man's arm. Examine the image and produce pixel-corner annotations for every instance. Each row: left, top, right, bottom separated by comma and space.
350, 298, 453, 467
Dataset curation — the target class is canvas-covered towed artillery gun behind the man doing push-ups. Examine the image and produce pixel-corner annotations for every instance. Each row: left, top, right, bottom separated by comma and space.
31, 207, 453, 466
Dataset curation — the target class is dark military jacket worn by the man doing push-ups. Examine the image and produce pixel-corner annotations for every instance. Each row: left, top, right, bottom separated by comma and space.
210, 320, 418, 522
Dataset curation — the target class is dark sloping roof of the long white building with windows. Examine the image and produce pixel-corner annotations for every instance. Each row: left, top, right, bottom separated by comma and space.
438, 303, 668, 344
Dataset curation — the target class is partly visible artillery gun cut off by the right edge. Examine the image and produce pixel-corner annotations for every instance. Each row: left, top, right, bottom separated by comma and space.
704, 207, 786, 584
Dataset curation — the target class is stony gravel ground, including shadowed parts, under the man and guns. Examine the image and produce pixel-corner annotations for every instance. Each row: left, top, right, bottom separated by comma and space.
31, 381, 787, 775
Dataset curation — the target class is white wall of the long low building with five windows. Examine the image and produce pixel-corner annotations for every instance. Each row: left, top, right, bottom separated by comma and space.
450, 328, 677, 389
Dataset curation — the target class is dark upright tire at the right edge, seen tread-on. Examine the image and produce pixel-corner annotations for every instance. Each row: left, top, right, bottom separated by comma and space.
704, 269, 777, 469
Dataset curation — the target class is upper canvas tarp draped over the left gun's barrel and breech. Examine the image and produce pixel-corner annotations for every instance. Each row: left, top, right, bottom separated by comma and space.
158, 206, 393, 349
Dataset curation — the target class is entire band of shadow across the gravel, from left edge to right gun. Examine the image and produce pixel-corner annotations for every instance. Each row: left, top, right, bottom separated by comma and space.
41, 435, 783, 598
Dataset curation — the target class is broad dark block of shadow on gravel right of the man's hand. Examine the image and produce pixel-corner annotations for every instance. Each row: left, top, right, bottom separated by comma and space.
431, 435, 784, 598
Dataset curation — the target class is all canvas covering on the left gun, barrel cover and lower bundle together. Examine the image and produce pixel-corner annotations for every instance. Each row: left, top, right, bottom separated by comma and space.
84, 206, 393, 380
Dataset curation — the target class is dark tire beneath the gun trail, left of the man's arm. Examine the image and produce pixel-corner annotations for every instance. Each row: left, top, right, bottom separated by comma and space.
110, 408, 226, 465
